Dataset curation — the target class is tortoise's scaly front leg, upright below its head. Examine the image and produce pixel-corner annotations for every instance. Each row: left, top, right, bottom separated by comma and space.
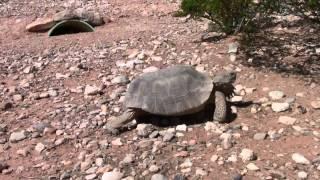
213, 91, 227, 122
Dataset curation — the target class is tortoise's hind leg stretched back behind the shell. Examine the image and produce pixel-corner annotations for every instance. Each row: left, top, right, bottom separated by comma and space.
106, 109, 136, 134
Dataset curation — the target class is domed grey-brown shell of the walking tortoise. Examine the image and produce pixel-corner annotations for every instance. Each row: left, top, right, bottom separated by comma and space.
125, 65, 213, 115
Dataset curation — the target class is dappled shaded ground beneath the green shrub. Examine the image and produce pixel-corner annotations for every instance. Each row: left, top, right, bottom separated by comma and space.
242, 16, 320, 82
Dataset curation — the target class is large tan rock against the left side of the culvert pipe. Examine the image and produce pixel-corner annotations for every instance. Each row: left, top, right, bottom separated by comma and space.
26, 17, 56, 32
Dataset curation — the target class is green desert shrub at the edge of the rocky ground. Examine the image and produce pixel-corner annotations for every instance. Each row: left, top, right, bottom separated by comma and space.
180, 0, 320, 34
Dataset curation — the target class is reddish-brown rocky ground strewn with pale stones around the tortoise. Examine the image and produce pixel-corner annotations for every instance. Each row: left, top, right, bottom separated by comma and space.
0, 0, 320, 180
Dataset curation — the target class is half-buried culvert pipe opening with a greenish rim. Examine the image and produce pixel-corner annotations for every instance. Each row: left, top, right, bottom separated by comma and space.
48, 20, 94, 36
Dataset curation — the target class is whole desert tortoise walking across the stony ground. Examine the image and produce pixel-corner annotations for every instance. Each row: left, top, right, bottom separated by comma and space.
106, 65, 236, 133
